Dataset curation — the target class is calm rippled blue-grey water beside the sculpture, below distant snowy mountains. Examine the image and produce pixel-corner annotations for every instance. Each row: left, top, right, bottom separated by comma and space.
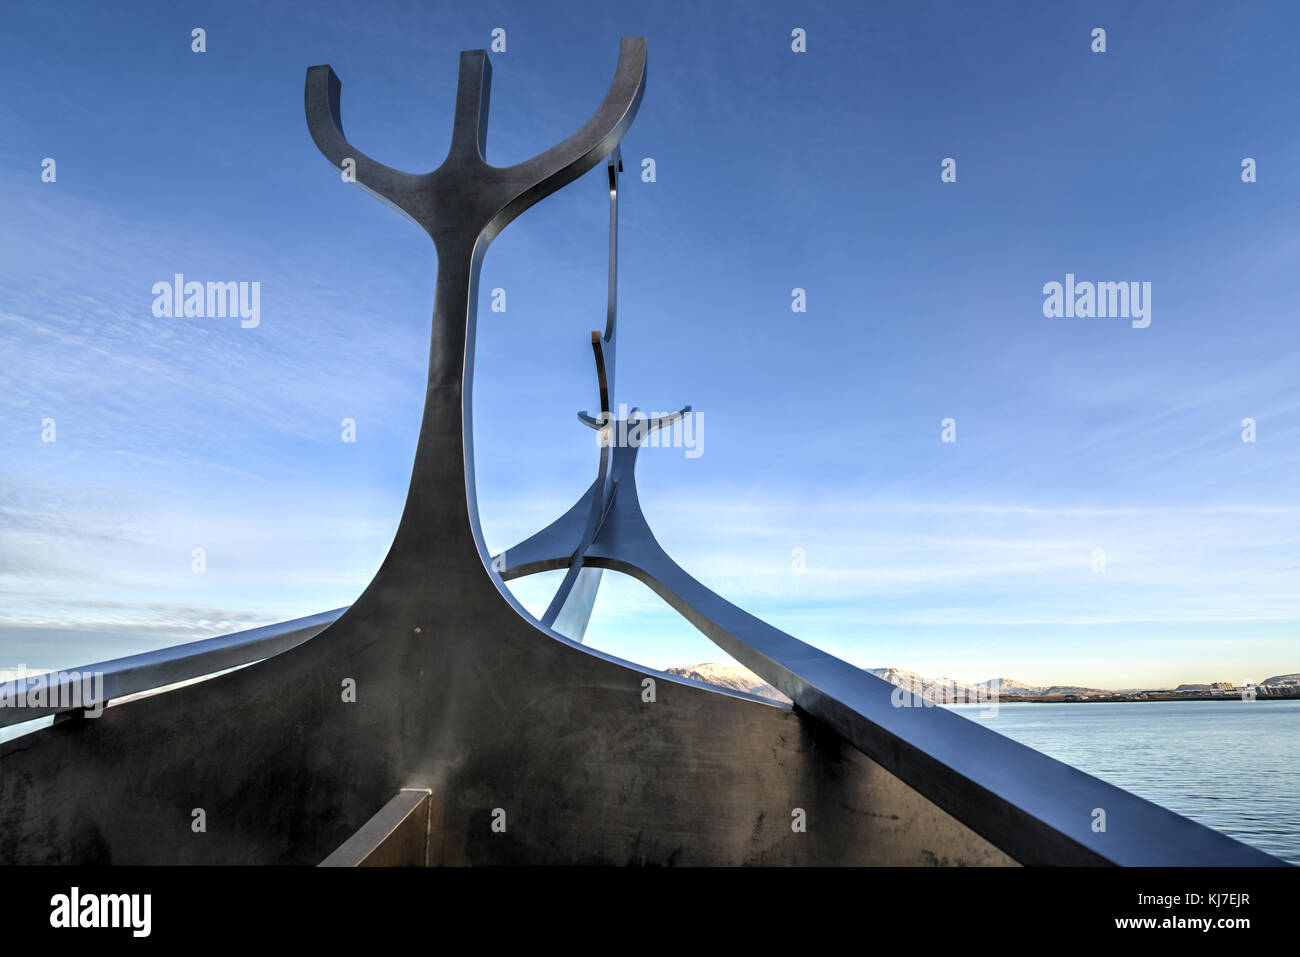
953, 700, 1300, 865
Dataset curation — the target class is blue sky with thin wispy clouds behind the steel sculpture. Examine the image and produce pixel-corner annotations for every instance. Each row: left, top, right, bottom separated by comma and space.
0, 3, 1300, 687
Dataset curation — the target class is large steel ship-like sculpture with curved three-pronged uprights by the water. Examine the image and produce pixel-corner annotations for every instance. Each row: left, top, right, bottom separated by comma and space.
0, 39, 1278, 865
